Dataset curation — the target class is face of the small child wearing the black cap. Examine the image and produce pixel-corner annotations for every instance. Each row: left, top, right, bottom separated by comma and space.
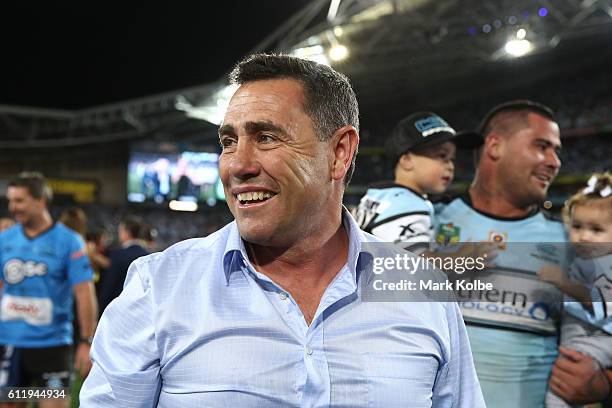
410, 142, 457, 194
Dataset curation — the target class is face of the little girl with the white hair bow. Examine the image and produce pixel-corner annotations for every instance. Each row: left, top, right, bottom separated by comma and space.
569, 199, 612, 257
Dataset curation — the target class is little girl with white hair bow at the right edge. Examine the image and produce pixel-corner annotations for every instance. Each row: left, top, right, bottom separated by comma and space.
539, 173, 612, 407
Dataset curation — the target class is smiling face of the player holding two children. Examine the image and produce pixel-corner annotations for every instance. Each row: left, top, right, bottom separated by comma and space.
500, 113, 561, 205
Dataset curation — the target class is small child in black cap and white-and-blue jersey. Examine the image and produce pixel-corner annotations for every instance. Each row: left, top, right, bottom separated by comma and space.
355, 112, 456, 252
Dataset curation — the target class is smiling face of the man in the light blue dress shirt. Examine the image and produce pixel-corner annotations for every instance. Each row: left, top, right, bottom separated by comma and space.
219, 79, 333, 245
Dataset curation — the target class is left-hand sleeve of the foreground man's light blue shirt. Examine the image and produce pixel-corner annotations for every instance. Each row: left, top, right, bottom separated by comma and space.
80, 258, 161, 408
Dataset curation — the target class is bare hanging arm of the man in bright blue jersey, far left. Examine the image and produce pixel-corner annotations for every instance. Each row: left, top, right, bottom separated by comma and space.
73, 281, 98, 378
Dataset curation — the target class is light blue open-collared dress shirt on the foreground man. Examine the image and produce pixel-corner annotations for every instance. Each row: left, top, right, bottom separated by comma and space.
80, 212, 484, 408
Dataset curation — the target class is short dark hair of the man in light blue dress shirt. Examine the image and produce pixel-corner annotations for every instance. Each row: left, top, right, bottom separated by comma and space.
229, 54, 359, 185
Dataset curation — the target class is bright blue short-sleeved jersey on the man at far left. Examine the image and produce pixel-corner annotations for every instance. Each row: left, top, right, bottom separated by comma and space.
0, 223, 93, 348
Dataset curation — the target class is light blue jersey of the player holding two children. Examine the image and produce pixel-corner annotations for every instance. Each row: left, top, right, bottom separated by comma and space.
436, 195, 568, 408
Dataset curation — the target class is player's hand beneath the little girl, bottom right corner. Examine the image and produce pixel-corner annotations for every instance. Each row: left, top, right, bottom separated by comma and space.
548, 347, 610, 404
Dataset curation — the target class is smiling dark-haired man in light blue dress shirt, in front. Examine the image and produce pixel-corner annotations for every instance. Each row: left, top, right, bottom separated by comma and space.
81, 55, 484, 408
